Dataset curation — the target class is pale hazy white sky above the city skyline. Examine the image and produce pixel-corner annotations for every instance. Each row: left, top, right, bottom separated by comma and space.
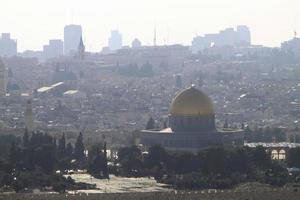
0, 0, 300, 51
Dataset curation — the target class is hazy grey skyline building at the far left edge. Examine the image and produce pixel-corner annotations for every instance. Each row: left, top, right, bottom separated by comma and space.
0, 33, 17, 57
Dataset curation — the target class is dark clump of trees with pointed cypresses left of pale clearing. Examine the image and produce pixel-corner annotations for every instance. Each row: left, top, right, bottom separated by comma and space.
0, 130, 95, 192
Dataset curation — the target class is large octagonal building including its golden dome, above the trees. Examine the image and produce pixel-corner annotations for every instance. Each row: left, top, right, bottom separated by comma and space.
140, 86, 244, 151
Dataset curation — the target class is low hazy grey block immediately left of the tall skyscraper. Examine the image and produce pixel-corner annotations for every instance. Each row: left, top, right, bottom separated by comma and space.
43, 40, 63, 59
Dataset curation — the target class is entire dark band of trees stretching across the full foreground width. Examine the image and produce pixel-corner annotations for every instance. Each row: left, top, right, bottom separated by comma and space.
0, 128, 300, 192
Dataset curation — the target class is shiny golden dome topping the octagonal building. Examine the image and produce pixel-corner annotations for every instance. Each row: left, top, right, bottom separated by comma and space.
170, 86, 214, 116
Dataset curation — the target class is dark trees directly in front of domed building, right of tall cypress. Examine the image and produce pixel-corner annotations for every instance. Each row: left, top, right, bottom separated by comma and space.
118, 145, 300, 189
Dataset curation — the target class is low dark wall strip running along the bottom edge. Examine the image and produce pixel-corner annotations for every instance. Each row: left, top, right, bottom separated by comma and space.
0, 189, 300, 200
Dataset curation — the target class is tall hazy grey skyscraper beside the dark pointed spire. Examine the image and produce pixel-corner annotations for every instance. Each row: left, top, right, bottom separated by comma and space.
64, 24, 82, 56
